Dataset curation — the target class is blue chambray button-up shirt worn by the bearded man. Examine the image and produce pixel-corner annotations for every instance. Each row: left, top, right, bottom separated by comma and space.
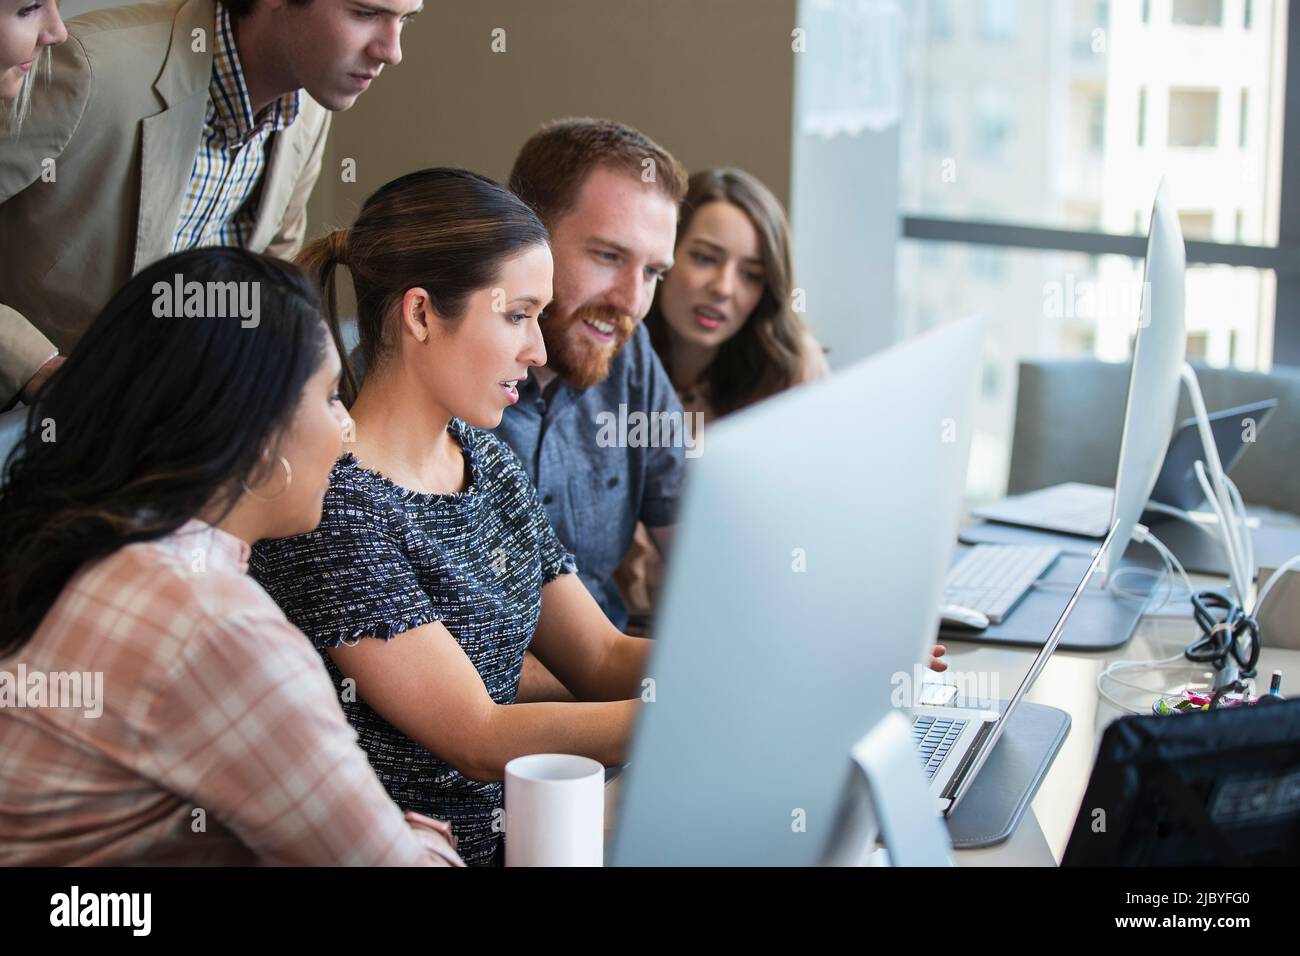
495, 325, 686, 628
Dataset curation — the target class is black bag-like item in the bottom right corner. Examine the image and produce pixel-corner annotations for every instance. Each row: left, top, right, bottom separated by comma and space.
1061, 698, 1300, 866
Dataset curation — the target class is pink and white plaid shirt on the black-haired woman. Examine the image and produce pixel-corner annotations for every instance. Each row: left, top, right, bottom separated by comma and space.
0, 520, 459, 865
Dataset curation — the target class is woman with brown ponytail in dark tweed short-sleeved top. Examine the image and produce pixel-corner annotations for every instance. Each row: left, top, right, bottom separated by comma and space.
252, 169, 649, 864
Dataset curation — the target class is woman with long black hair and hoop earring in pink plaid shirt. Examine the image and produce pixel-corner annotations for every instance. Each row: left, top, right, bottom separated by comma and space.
0, 248, 458, 865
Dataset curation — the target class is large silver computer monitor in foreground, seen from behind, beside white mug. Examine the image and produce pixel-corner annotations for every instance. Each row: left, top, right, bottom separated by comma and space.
610, 319, 982, 865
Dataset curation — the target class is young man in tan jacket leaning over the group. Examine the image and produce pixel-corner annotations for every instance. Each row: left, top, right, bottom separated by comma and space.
0, 0, 423, 408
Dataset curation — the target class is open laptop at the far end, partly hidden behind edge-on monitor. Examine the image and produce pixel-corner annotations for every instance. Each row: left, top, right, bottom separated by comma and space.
971, 399, 1278, 538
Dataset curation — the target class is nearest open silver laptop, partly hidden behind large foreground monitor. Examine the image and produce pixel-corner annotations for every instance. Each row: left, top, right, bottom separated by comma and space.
911, 523, 1118, 816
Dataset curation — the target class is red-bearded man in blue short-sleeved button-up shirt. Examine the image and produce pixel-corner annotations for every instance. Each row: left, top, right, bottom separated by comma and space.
497, 118, 690, 639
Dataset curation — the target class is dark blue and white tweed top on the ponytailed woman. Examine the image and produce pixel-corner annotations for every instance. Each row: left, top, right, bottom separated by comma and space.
251, 419, 576, 864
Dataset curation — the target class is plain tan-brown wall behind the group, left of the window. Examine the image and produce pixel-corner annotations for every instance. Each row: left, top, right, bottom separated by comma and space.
308, 0, 796, 243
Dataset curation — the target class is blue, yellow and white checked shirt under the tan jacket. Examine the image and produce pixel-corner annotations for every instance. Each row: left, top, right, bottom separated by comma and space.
172, 3, 302, 252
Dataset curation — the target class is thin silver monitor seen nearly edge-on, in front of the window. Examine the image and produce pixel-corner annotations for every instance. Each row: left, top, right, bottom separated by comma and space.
1105, 182, 1187, 581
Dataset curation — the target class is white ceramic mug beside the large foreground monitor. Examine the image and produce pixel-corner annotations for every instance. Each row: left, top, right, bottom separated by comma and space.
506, 753, 605, 866
